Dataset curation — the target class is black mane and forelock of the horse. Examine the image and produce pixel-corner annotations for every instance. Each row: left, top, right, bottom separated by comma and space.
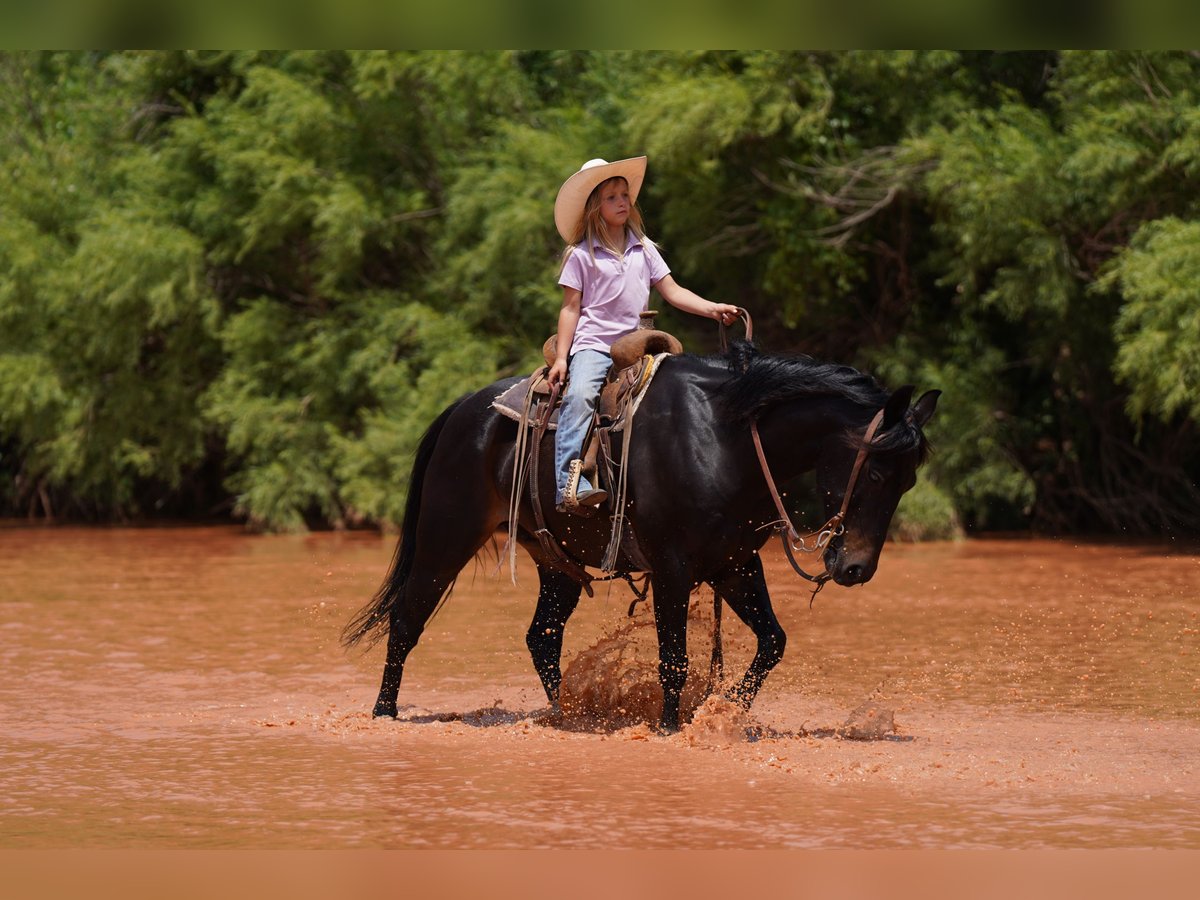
719, 341, 929, 462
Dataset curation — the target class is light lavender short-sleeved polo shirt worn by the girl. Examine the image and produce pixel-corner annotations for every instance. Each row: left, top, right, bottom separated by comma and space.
558, 233, 671, 353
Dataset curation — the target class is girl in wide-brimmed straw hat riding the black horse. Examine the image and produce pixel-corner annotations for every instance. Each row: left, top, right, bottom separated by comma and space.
547, 156, 738, 512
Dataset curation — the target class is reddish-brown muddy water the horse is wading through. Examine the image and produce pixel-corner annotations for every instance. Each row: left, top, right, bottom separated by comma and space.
0, 526, 1200, 848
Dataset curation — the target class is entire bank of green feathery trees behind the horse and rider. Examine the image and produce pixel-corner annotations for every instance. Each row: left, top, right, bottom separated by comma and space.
0, 50, 1200, 536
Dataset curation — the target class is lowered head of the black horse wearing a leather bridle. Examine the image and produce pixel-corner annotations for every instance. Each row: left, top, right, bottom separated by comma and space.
817, 385, 941, 587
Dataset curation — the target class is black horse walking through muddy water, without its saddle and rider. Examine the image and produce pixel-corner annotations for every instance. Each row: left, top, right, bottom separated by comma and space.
343, 342, 940, 731
